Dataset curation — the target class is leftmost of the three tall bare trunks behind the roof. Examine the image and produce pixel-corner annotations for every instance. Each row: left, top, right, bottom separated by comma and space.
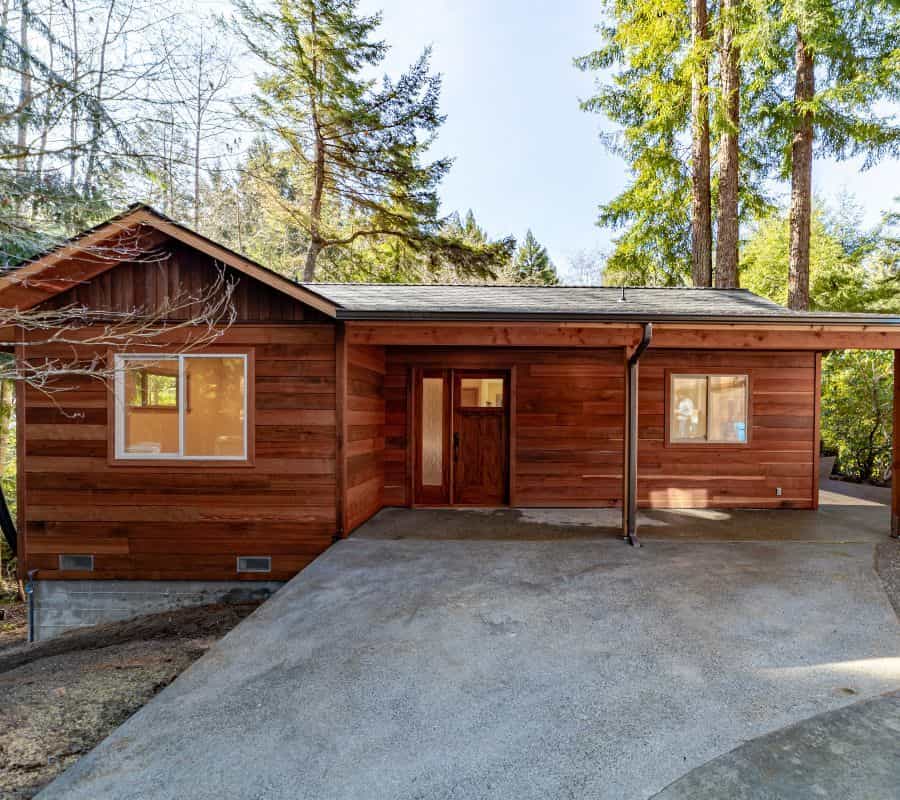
691, 0, 712, 286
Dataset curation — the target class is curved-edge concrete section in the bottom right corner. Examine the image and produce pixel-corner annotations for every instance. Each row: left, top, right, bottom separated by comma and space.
653, 692, 900, 800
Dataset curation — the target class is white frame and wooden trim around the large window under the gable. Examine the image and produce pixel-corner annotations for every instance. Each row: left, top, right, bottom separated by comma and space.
108, 348, 255, 467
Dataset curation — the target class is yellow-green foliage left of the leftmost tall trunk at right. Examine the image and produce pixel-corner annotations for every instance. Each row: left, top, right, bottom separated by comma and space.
575, 0, 692, 285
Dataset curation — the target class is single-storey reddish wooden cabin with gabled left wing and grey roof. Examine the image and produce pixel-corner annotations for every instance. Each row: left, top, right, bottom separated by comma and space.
0, 206, 900, 636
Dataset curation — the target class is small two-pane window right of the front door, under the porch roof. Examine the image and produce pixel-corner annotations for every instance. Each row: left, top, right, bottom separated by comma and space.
669, 374, 750, 444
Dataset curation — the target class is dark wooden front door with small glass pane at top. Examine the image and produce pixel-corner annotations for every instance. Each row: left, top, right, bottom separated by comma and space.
452, 371, 509, 506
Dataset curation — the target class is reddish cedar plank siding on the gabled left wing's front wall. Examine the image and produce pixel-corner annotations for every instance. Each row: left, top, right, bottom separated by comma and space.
19, 244, 338, 580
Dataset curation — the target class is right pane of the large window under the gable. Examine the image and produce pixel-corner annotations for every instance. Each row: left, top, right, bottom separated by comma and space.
184, 356, 246, 458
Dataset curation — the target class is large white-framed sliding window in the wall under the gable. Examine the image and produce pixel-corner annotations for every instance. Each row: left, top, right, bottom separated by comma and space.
114, 353, 248, 461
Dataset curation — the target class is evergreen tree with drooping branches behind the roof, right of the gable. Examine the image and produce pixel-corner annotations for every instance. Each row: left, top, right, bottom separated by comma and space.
236, 0, 511, 280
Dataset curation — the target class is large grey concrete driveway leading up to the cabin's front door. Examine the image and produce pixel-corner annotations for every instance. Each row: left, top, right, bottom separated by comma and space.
41, 512, 900, 800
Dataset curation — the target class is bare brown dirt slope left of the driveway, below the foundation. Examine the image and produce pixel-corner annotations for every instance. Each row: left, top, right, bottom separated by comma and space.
0, 603, 257, 800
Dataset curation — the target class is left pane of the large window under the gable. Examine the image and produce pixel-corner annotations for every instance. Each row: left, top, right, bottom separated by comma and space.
122, 359, 178, 456
